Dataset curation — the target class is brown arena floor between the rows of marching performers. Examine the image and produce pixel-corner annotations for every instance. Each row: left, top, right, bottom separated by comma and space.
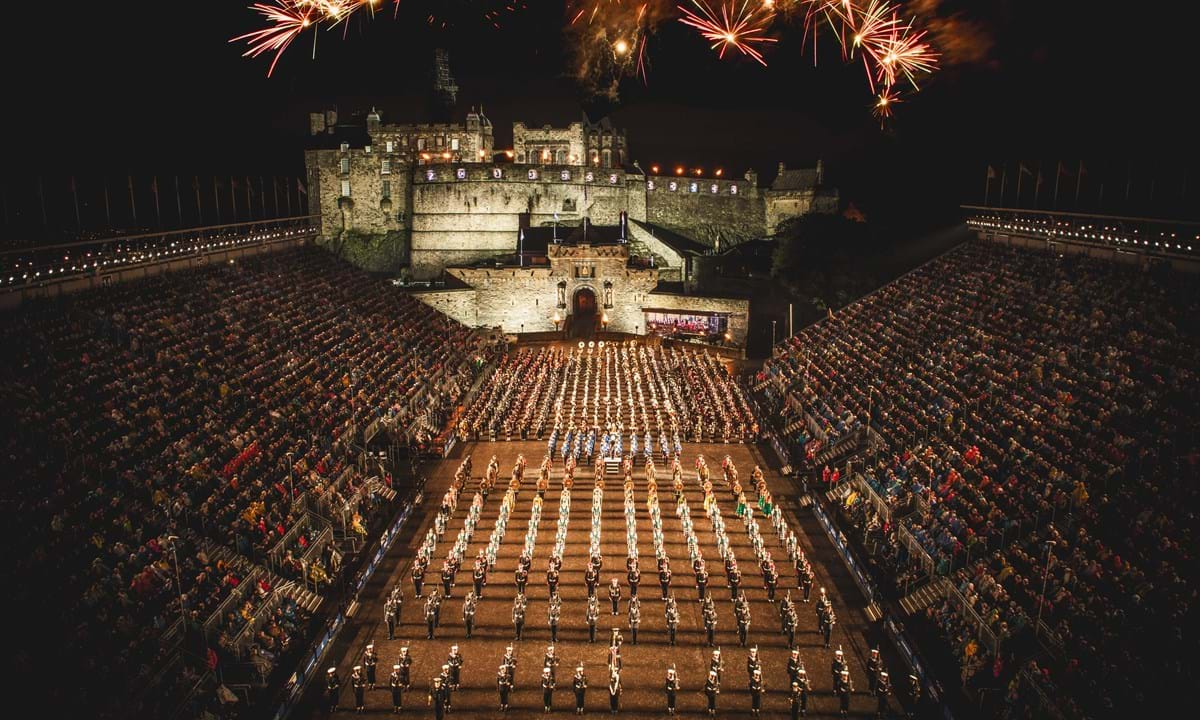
307, 442, 906, 718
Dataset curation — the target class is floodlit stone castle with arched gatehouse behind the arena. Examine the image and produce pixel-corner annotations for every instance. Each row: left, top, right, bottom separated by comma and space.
305, 109, 839, 344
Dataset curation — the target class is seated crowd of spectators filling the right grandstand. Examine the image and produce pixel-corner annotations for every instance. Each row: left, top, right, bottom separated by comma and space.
756, 242, 1200, 714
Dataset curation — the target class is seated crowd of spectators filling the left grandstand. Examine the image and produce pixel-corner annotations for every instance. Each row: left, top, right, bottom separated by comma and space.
0, 247, 478, 713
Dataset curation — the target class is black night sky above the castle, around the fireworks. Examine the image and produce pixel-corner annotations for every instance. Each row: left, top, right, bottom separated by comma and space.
2, 0, 1200, 240
